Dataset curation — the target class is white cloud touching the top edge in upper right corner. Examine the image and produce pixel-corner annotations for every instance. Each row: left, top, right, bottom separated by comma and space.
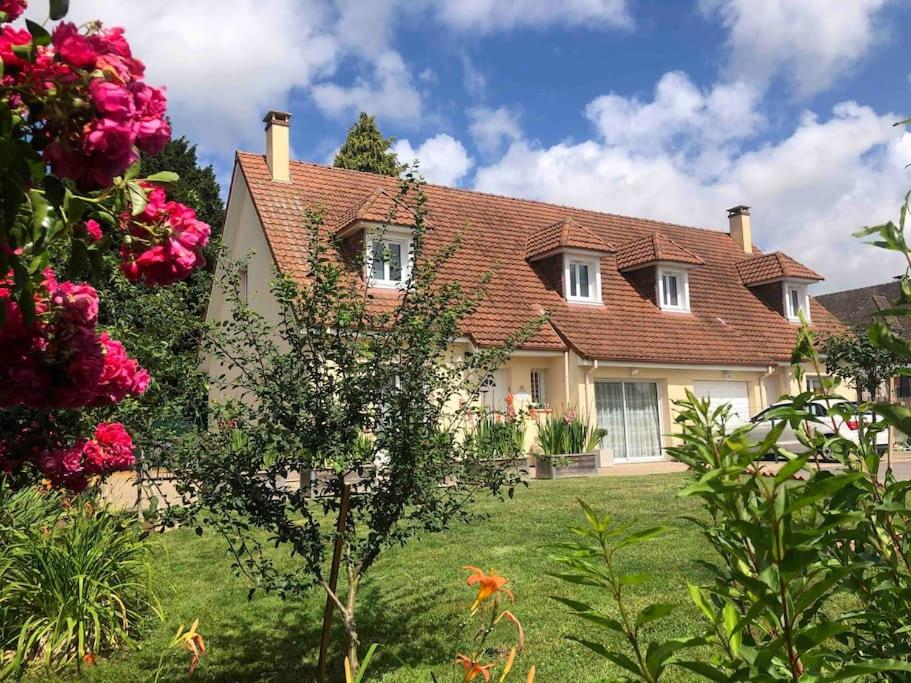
700, 0, 892, 97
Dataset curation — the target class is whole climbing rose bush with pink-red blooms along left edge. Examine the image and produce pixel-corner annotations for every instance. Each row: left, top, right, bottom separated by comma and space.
0, 0, 210, 490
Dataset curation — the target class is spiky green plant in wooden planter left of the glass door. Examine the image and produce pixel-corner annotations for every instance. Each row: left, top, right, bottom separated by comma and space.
535, 410, 607, 479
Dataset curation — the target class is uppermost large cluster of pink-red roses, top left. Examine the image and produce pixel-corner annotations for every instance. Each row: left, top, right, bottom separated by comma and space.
0, 17, 171, 190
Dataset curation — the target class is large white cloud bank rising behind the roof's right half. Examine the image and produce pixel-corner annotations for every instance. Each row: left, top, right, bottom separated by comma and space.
474, 83, 911, 290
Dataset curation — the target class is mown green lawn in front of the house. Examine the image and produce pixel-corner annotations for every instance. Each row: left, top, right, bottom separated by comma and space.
41, 474, 710, 683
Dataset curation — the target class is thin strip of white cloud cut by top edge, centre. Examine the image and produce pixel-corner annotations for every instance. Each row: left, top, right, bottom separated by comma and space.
437, 0, 633, 33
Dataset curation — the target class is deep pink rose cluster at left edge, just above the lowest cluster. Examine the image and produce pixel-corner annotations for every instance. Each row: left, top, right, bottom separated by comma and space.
0, 269, 149, 408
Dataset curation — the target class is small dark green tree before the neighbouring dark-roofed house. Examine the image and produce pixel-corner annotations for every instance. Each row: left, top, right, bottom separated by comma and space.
823, 330, 905, 400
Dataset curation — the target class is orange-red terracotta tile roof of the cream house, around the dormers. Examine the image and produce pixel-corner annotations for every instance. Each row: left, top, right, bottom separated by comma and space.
237, 153, 842, 365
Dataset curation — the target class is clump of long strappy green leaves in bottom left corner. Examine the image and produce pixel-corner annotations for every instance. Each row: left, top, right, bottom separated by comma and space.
0, 487, 159, 678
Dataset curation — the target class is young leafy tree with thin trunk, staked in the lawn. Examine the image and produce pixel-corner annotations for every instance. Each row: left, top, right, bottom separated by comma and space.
170, 180, 543, 680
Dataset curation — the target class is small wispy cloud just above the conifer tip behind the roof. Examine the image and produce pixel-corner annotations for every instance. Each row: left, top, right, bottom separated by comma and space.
312, 50, 423, 123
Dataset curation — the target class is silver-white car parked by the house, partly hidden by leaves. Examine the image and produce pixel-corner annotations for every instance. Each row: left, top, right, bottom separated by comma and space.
750, 398, 889, 457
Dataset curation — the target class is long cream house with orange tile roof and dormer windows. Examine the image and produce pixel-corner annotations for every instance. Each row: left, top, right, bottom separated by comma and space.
208, 112, 842, 462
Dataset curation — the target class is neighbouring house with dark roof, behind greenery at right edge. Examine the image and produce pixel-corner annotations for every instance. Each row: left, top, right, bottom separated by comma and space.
817, 280, 911, 405
